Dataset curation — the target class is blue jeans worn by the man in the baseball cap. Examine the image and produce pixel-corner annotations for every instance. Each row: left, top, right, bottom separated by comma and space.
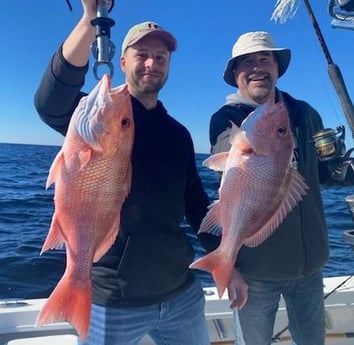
78, 279, 210, 345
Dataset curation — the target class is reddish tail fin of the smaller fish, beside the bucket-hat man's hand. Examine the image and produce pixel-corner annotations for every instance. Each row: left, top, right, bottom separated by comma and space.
189, 250, 234, 298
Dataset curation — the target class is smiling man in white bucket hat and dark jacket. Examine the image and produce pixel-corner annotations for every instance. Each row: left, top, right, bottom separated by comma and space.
203, 31, 346, 345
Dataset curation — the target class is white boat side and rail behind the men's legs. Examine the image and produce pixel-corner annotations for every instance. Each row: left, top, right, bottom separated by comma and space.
0, 276, 354, 345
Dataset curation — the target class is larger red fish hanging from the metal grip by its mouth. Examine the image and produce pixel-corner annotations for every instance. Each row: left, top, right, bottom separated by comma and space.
36, 75, 134, 339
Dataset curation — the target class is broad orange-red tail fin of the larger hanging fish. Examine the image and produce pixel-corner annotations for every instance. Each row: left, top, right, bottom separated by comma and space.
36, 274, 92, 340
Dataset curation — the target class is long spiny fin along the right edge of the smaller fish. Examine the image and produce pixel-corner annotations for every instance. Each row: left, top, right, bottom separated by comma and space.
244, 169, 308, 247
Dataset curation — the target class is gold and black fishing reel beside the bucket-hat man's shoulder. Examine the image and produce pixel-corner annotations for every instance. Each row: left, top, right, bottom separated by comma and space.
312, 125, 354, 181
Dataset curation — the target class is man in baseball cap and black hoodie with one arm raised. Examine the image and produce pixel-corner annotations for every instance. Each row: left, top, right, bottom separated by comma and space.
35, 0, 209, 345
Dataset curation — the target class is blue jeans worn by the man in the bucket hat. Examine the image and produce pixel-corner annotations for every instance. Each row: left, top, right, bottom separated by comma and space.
234, 272, 325, 345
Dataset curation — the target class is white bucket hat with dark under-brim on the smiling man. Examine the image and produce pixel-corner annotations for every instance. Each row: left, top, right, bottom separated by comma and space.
224, 31, 291, 86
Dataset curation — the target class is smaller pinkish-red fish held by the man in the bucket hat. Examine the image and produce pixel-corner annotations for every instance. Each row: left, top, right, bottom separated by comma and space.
190, 102, 308, 297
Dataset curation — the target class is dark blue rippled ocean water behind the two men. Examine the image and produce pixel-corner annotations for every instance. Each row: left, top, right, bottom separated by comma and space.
0, 144, 354, 299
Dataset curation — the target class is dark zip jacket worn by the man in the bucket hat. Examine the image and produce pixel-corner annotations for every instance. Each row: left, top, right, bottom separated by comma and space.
200, 92, 352, 280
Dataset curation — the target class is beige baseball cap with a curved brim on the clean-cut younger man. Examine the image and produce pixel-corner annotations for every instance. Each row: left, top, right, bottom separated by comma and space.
122, 22, 177, 55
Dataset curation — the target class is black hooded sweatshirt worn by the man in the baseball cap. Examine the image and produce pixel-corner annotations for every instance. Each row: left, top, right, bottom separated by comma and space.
35, 47, 209, 306
